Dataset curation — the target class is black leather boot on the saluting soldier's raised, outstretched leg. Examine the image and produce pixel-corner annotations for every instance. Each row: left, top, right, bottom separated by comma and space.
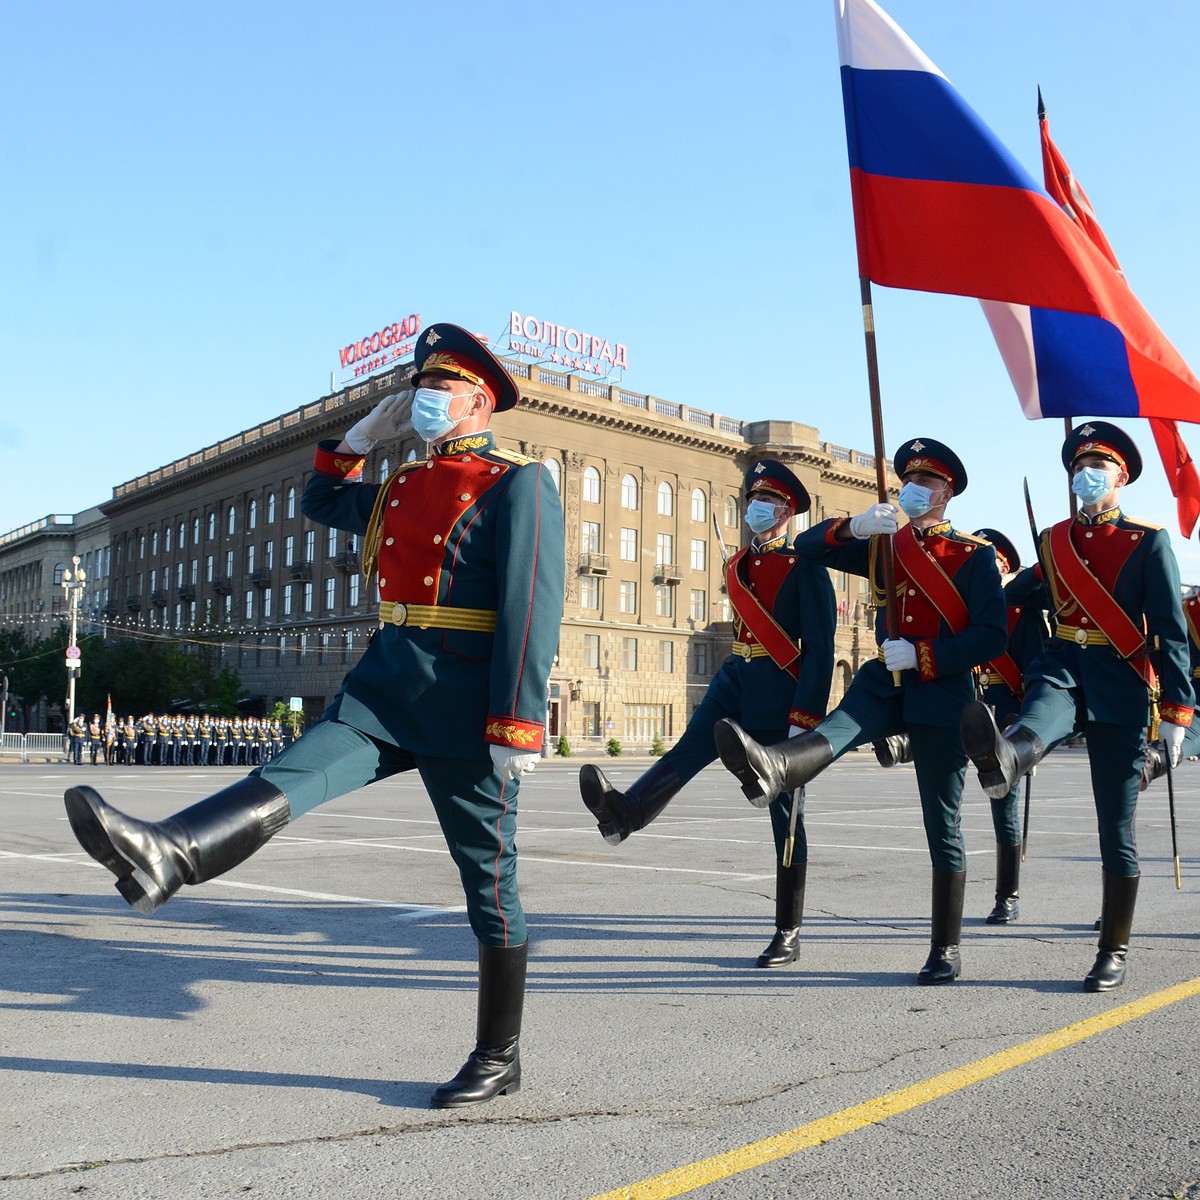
65, 775, 292, 913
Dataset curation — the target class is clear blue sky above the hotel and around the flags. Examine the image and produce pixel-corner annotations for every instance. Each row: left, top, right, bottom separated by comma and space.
7, 0, 1200, 580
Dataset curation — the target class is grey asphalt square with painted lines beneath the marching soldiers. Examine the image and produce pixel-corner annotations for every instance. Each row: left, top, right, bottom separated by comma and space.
0, 750, 1200, 1200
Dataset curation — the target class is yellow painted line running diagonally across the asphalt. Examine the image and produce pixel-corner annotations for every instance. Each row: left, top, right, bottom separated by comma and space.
593, 978, 1200, 1200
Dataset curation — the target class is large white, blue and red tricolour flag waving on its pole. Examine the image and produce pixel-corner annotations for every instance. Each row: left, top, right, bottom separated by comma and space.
834, 0, 1200, 432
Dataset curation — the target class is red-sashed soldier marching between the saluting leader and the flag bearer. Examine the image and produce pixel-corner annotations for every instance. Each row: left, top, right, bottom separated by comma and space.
580, 460, 836, 967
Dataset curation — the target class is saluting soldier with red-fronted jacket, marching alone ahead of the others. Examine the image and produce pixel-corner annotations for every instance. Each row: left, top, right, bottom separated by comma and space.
66, 324, 564, 1108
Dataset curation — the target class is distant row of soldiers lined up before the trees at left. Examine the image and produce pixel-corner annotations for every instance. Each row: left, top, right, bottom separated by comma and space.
67, 713, 294, 767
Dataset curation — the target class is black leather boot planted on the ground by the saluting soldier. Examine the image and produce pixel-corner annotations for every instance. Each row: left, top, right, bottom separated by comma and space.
431, 942, 529, 1109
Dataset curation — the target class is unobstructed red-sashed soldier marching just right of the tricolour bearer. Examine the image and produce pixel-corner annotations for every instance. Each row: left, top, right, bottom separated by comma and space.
962, 421, 1195, 991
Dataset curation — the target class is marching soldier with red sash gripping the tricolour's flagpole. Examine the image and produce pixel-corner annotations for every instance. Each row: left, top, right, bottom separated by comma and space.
714, 438, 1008, 984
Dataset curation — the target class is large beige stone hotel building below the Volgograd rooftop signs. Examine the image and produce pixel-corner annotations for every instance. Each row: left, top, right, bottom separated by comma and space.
0, 362, 895, 746
